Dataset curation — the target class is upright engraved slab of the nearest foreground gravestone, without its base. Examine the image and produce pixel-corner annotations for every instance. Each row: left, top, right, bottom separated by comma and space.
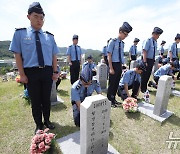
80, 95, 111, 154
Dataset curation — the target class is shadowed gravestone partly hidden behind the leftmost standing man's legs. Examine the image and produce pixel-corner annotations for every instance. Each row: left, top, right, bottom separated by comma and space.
50, 80, 64, 105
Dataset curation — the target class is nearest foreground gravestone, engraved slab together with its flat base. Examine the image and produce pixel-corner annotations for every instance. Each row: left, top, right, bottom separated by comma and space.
57, 95, 119, 154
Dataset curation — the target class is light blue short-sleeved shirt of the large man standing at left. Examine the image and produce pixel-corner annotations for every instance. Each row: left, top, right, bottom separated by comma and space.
9, 27, 59, 68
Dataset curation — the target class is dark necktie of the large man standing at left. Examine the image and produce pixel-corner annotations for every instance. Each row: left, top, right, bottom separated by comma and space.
35, 31, 44, 67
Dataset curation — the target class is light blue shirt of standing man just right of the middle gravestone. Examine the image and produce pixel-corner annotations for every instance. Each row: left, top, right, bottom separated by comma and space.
108, 38, 124, 64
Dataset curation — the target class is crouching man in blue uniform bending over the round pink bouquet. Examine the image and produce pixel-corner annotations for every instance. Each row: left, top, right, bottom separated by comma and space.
117, 62, 146, 100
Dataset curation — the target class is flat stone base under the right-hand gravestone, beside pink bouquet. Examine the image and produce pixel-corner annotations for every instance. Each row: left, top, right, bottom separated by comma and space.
138, 102, 173, 123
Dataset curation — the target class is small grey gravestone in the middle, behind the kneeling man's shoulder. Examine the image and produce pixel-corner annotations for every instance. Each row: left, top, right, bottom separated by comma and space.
97, 63, 107, 90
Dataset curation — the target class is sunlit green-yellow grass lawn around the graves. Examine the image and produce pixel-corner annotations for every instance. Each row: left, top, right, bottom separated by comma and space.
0, 80, 180, 154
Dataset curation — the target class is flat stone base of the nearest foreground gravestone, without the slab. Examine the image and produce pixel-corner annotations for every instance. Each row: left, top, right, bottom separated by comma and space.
56, 131, 120, 154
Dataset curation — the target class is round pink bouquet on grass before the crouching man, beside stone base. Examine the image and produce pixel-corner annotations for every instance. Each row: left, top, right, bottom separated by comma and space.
122, 97, 138, 112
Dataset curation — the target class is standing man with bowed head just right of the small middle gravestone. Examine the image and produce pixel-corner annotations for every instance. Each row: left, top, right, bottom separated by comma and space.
107, 22, 132, 107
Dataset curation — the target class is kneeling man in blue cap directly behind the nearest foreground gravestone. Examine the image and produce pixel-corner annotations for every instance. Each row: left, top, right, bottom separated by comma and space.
71, 65, 101, 127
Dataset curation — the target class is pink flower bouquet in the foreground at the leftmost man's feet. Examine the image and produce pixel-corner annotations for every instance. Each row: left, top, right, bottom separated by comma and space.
30, 128, 55, 154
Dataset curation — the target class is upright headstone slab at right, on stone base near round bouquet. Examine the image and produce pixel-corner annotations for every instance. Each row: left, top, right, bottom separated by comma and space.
153, 75, 172, 116
